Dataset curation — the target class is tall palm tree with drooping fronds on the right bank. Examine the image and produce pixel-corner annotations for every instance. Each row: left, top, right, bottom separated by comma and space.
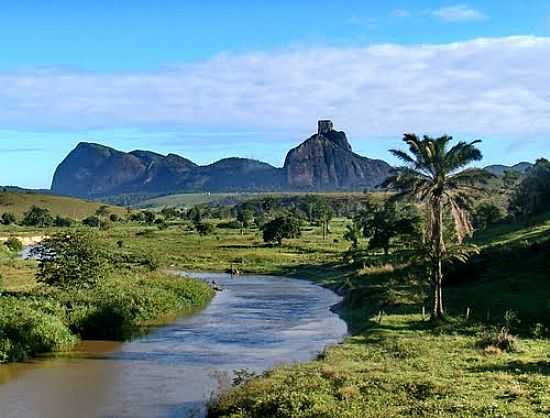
383, 134, 491, 319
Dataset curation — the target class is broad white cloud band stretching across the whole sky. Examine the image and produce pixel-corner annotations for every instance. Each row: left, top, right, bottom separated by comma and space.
0, 37, 550, 139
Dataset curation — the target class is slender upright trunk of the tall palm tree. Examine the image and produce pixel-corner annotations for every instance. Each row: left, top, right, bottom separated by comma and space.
432, 197, 445, 319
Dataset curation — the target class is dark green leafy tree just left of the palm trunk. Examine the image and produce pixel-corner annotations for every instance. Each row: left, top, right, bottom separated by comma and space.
354, 200, 420, 255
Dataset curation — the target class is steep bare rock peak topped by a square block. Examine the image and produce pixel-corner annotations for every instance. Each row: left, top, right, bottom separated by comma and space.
284, 121, 391, 191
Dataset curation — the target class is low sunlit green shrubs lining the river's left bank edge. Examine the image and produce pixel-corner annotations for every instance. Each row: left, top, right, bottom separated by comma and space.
0, 273, 214, 363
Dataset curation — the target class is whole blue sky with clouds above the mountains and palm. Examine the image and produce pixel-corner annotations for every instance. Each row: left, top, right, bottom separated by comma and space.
0, 0, 550, 188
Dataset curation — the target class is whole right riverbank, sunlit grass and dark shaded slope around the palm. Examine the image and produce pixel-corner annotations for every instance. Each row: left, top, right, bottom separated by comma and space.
188, 222, 550, 418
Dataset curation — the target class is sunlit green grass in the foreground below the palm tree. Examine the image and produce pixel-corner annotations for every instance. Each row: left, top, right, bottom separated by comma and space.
210, 315, 550, 418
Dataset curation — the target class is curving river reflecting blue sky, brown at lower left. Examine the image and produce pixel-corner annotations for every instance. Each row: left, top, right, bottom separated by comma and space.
0, 273, 347, 418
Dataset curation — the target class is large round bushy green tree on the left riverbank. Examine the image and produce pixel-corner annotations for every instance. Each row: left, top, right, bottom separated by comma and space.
31, 231, 111, 288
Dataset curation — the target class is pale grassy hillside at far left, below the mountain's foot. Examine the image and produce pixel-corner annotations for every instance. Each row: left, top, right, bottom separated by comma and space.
0, 192, 126, 220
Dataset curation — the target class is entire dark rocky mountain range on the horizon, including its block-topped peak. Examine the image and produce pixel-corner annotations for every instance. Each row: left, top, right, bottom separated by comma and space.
51, 121, 391, 199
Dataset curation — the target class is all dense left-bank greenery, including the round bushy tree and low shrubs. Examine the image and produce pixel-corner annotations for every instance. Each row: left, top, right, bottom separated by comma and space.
0, 230, 213, 363
